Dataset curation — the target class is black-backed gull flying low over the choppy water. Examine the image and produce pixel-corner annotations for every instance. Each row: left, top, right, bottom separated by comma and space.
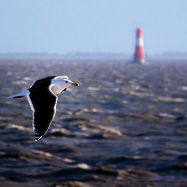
8, 76, 79, 141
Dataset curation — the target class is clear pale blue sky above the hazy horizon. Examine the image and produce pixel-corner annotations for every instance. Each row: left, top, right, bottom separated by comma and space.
0, 0, 187, 54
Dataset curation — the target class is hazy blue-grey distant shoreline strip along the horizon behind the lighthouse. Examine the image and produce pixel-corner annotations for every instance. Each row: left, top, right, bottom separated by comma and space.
0, 52, 187, 61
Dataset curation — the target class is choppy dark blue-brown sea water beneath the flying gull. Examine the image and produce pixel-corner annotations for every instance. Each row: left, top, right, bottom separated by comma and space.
0, 60, 187, 187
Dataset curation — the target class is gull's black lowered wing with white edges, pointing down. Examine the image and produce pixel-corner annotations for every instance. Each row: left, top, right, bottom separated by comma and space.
27, 89, 57, 141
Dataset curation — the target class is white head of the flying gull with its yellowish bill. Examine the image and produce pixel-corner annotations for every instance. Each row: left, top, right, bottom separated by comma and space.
50, 76, 79, 95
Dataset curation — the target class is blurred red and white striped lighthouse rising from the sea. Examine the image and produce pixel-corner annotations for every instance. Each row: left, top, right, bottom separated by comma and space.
133, 27, 145, 64
